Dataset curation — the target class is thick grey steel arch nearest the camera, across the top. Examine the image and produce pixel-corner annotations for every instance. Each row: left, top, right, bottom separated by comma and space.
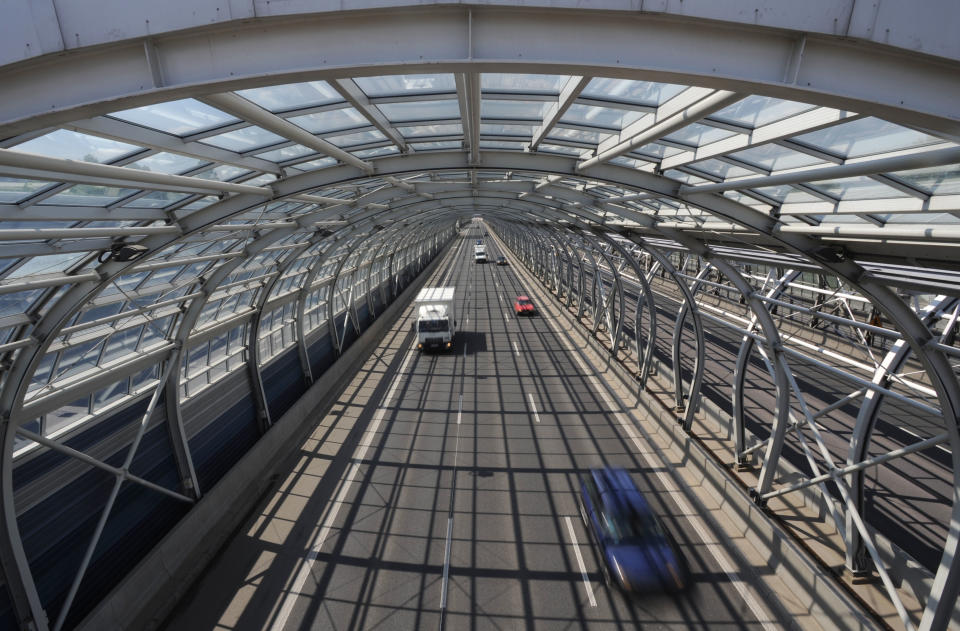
0, 5, 960, 137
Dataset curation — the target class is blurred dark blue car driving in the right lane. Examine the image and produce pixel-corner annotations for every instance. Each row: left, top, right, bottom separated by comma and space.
580, 468, 690, 592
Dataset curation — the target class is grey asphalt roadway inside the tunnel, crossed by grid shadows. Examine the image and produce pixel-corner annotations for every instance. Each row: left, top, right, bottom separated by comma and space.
166, 227, 774, 630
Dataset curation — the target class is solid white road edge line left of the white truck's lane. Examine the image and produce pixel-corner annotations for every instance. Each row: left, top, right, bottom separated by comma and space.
270, 351, 414, 631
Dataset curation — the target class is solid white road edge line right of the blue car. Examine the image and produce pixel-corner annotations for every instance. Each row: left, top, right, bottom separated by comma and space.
557, 333, 779, 631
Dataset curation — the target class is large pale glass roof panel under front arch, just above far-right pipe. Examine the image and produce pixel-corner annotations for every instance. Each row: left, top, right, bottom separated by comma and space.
793, 117, 943, 158
